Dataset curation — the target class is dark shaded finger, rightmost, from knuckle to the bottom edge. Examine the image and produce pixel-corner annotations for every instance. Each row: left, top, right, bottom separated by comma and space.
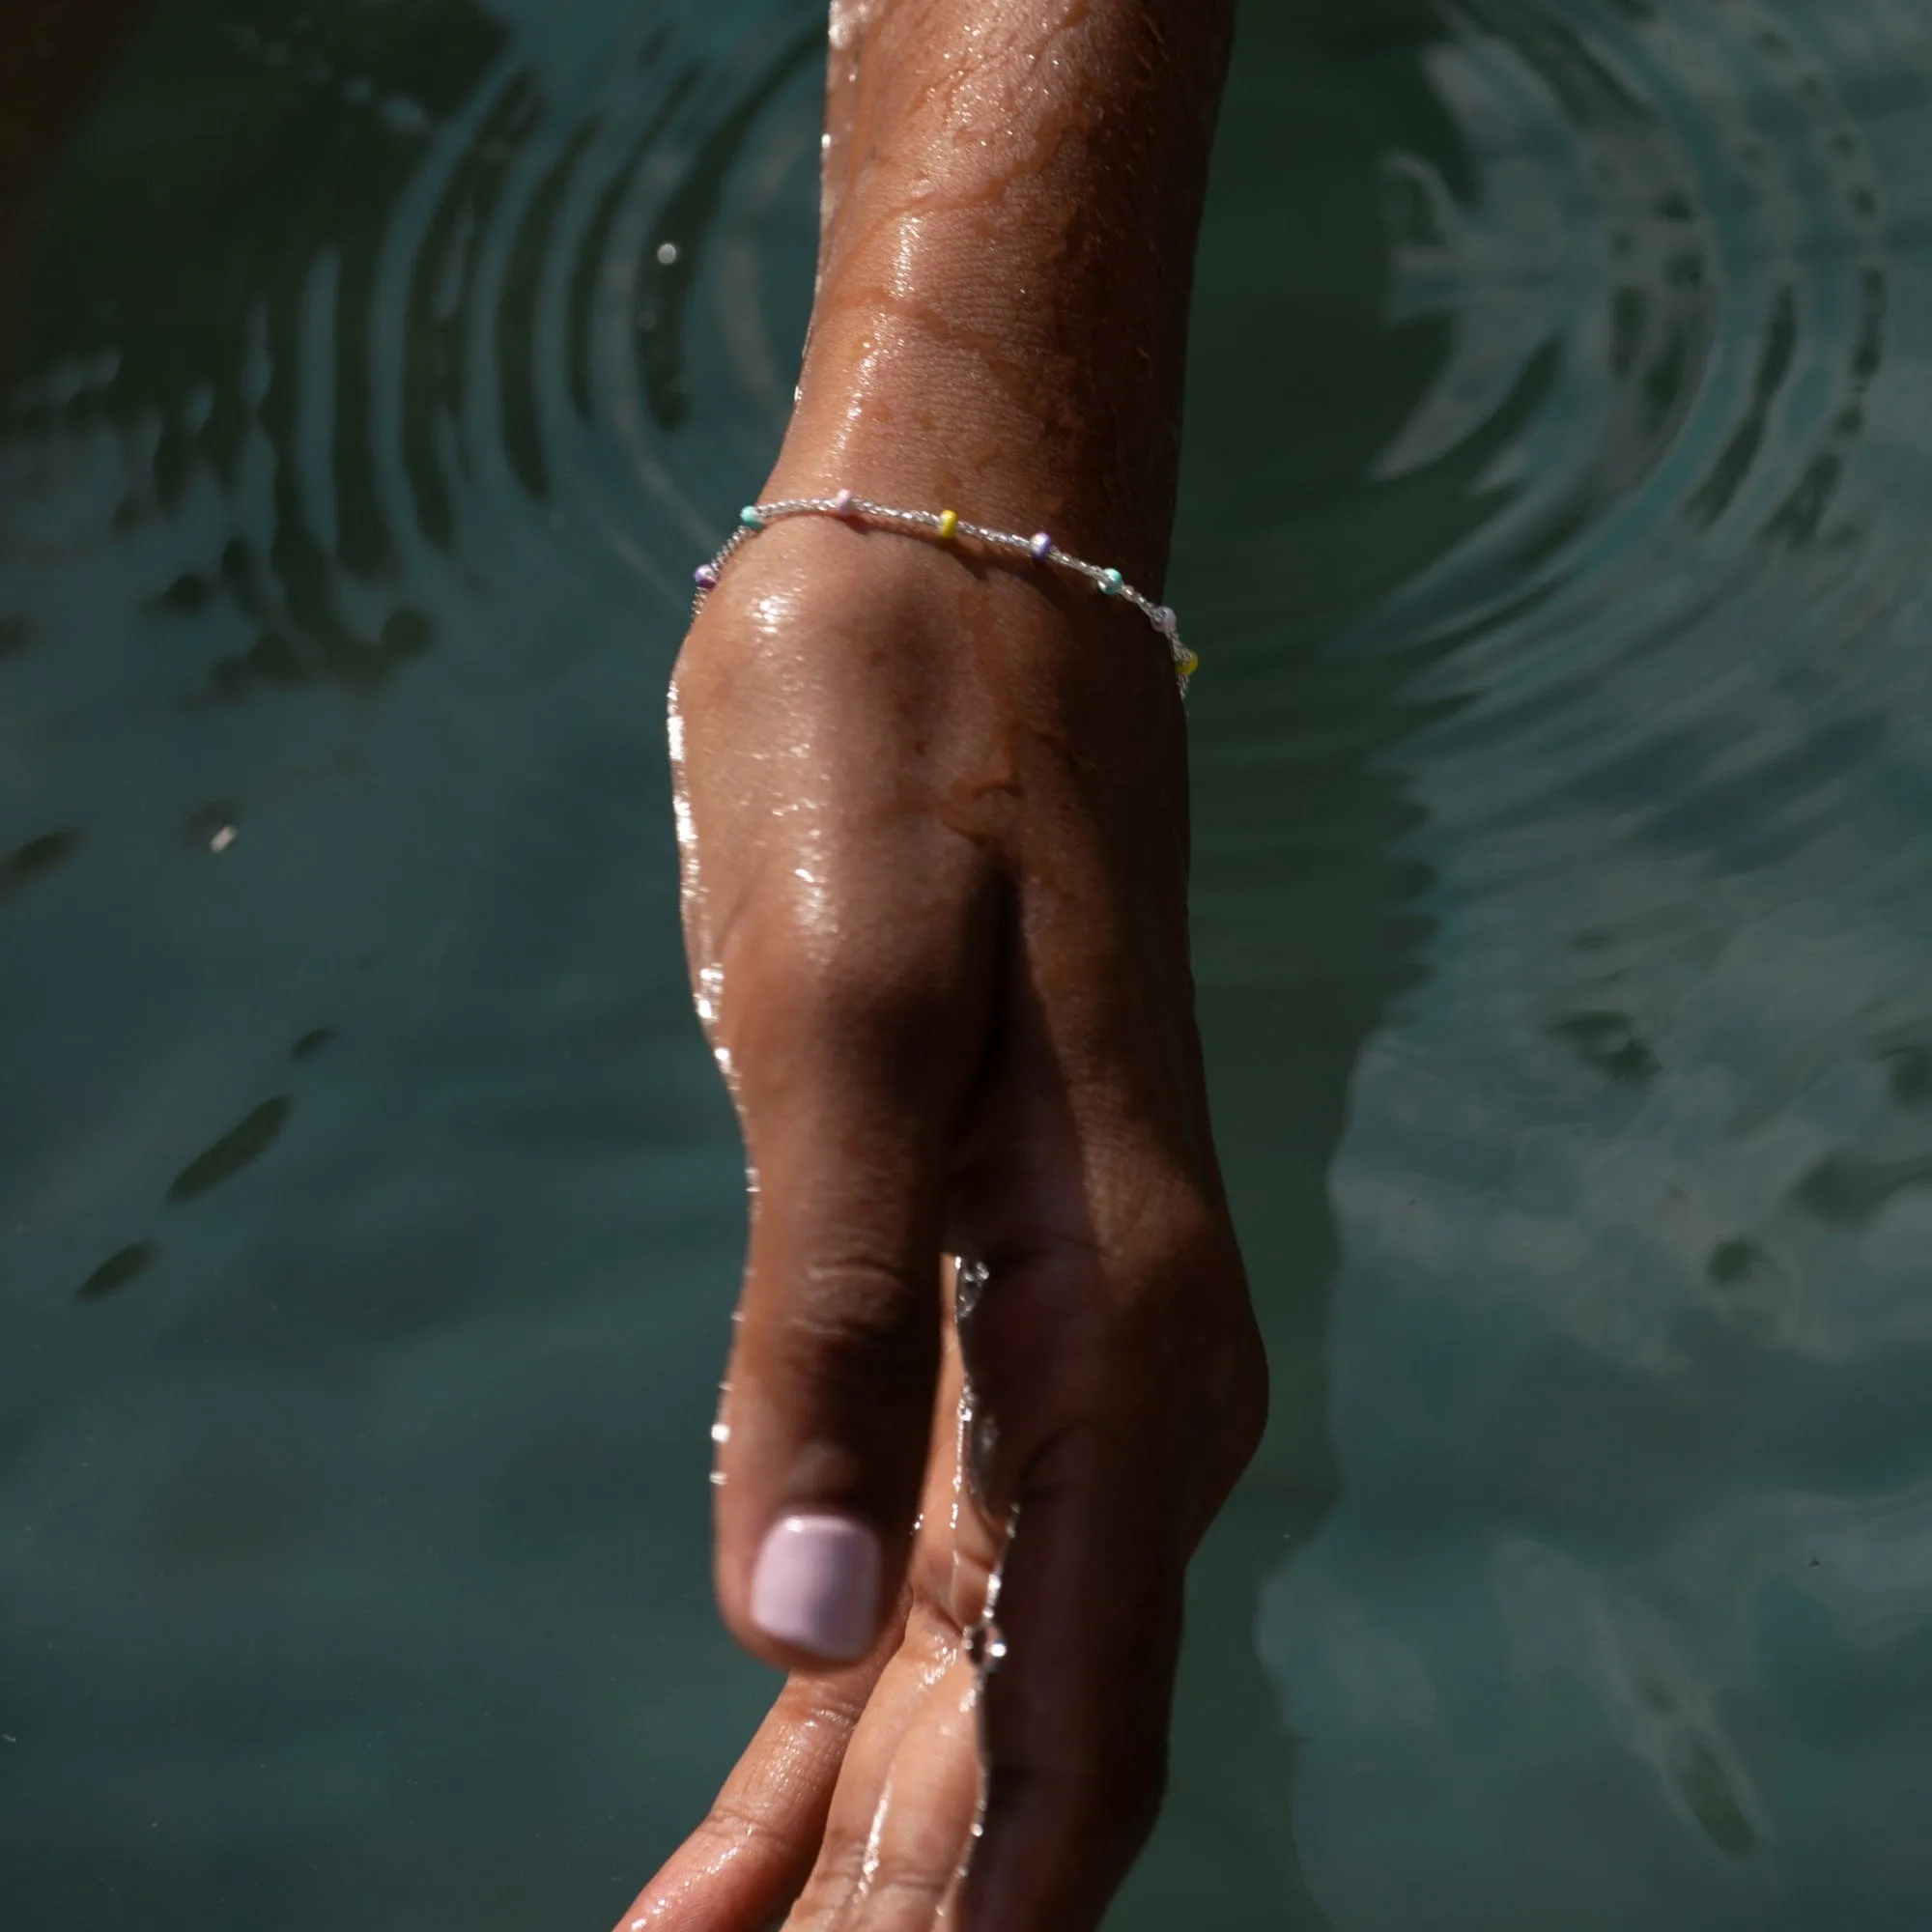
947, 1221, 1260, 1932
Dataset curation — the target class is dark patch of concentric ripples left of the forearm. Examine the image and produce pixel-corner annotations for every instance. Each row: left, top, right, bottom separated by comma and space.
0, 0, 823, 697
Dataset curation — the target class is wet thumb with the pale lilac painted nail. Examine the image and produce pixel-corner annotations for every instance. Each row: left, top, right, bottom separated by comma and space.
717, 869, 997, 1669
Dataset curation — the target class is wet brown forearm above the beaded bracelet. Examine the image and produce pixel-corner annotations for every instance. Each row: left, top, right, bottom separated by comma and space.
779, 0, 1233, 589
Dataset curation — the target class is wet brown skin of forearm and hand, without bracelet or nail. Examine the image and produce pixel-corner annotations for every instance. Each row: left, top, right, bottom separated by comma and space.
622, 0, 1265, 1932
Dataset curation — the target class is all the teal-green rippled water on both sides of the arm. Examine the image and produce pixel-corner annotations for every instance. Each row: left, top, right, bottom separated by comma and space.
0, 0, 1932, 1932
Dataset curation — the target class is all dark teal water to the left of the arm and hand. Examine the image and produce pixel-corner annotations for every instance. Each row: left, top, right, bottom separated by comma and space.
0, 11, 823, 1932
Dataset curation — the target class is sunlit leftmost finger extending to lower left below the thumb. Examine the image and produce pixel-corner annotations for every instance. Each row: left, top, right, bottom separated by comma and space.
618, 1644, 889, 1932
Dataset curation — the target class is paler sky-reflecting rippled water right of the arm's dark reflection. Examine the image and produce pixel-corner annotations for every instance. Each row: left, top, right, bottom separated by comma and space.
1196, 0, 1932, 1932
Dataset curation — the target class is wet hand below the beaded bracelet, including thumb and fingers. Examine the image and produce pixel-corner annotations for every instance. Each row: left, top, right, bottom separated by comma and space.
624, 514, 1265, 1932
